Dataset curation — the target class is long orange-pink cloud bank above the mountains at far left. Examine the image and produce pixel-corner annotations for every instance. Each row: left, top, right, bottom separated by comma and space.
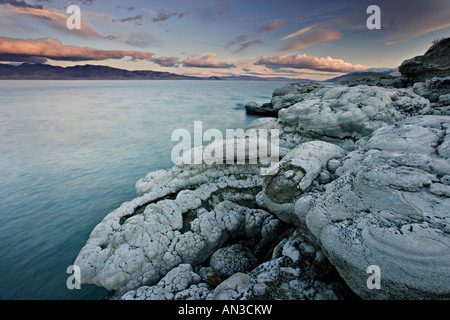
0, 37, 178, 66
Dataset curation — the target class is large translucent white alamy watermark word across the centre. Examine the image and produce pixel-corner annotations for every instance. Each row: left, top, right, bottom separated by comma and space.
171, 121, 279, 175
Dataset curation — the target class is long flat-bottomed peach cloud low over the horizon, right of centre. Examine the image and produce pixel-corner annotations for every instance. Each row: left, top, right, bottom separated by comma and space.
255, 54, 368, 73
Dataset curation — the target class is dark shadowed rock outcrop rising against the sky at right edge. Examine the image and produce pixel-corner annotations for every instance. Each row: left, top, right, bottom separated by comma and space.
398, 38, 450, 81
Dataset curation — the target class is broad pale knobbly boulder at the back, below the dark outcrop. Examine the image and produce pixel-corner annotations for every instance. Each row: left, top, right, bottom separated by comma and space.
278, 86, 430, 149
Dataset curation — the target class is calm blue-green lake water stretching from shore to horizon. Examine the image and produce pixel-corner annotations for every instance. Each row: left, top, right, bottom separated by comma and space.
0, 81, 283, 300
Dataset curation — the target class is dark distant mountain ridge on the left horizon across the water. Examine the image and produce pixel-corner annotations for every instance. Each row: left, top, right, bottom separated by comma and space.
0, 63, 203, 80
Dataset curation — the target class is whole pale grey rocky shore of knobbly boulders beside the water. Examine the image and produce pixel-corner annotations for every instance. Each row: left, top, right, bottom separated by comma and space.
74, 39, 450, 300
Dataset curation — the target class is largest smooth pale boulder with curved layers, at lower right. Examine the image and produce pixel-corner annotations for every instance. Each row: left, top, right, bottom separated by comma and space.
306, 116, 450, 299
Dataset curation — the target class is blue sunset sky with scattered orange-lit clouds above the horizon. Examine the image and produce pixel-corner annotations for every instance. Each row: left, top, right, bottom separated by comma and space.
0, 0, 450, 80
